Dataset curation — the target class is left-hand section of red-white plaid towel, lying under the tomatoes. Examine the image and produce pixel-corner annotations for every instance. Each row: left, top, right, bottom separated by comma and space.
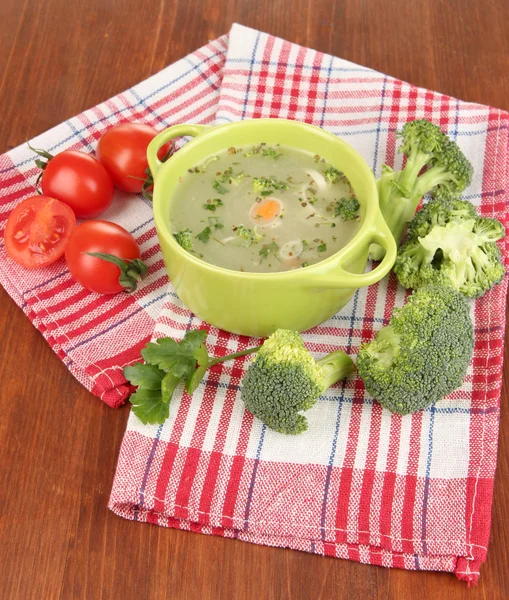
0, 36, 227, 407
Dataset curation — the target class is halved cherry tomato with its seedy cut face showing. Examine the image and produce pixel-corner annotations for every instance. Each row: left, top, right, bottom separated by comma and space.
4, 196, 76, 268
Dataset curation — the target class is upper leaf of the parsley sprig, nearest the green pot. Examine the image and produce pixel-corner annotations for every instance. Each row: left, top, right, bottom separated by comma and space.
141, 329, 207, 378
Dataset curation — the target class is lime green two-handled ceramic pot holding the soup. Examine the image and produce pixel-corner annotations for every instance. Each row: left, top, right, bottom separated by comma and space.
147, 119, 396, 337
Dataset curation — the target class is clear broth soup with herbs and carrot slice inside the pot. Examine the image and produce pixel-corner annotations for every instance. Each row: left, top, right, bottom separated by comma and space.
169, 143, 359, 273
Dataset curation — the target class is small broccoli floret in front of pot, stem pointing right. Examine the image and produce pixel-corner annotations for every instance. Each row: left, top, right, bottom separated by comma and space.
242, 329, 354, 434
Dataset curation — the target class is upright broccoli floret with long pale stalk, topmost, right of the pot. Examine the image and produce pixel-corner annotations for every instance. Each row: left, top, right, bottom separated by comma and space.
370, 119, 472, 260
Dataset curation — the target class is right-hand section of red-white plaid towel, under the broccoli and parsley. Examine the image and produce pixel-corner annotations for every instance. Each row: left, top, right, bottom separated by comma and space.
110, 25, 509, 581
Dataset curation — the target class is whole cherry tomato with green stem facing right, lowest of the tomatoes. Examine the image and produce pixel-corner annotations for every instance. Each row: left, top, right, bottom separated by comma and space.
65, 221, 140, 294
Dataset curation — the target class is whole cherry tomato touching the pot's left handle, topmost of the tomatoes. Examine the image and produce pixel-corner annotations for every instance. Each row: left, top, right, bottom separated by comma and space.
96, 123, 170, 193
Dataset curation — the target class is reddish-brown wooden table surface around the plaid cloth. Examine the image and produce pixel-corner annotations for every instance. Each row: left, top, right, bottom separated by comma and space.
0, 0, 509, 600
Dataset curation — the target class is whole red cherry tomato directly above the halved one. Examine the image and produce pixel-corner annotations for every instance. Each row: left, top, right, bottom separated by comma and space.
41, 150, 114, 219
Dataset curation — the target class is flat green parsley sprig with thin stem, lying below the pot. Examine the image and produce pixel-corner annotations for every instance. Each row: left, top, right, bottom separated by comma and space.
124, 329, 261, 425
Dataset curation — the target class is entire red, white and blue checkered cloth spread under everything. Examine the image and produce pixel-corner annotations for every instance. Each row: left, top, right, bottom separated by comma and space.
0, 25, 509, 582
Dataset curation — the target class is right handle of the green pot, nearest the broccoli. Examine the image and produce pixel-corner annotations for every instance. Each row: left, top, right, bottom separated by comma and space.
310, 213, 397, 288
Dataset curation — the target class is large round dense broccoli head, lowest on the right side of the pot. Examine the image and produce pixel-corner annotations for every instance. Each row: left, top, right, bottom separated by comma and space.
357, 285, 474, 415
